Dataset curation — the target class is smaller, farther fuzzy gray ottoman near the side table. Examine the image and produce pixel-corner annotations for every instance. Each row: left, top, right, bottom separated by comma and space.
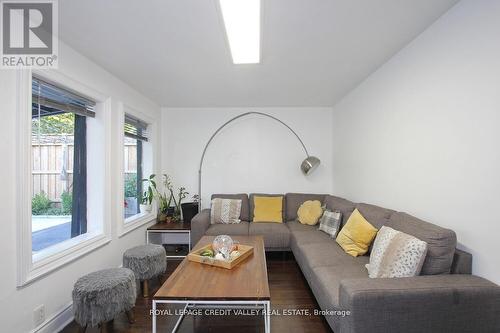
123, 244, 167, 297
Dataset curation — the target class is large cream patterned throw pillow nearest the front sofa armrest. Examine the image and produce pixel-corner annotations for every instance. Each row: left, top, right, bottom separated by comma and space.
366, 226, 427, 278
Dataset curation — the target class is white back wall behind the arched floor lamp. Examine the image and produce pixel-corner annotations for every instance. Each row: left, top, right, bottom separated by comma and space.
161, 107, 332, 206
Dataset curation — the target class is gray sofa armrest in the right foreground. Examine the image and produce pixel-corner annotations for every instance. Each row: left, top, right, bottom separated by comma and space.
339, 274, 500, 333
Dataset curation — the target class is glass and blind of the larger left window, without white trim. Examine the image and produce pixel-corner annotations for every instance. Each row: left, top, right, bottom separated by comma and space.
31, 76, 95, 255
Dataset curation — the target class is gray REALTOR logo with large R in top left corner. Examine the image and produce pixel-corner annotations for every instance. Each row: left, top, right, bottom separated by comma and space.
0, 0, 58, 68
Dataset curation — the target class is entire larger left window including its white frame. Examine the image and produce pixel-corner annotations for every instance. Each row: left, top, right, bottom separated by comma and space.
15, 70, 111, 287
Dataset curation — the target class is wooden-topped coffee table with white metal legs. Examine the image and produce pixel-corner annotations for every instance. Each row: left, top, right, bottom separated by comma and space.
152, 236, 271, 333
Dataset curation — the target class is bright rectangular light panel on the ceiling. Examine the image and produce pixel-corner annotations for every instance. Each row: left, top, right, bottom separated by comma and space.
219, 0, 260, 64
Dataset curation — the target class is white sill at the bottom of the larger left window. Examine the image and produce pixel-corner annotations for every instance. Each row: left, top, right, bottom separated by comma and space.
18, 232, 111, 287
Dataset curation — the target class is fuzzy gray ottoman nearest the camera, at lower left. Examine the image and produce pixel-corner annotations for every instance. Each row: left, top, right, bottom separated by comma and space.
73, 268, 136, 330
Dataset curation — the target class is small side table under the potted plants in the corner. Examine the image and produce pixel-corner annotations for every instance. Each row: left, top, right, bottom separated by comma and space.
146, 222, 191, 260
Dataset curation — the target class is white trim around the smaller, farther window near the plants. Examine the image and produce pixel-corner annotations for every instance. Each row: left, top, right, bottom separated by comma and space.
116, 102, 157, 237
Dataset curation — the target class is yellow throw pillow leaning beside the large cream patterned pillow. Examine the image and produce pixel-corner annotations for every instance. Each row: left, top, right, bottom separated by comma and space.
336, 209, 378, 257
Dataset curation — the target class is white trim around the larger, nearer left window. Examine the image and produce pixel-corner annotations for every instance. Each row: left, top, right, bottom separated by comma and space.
16, 70, 111, 287
